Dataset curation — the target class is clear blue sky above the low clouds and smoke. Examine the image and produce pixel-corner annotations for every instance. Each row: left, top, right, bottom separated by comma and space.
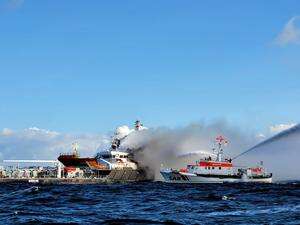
0, 0, 300, 132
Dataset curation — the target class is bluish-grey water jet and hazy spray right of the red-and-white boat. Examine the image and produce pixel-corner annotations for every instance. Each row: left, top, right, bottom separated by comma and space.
237, 124, 300, 180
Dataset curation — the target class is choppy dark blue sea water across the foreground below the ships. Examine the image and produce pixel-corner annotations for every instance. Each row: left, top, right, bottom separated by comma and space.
0, 182, 300, 224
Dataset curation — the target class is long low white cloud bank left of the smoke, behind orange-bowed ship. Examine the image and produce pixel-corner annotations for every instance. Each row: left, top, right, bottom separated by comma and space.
0, 127, 109, 159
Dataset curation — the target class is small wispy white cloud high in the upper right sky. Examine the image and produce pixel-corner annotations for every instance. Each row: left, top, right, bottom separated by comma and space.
275, 16, 300, 45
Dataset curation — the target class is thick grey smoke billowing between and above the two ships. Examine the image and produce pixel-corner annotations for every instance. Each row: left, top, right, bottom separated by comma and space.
121, 121, 258, 180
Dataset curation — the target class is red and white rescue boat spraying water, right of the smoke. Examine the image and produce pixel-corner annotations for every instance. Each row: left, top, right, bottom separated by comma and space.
160, 136, 272, 183
